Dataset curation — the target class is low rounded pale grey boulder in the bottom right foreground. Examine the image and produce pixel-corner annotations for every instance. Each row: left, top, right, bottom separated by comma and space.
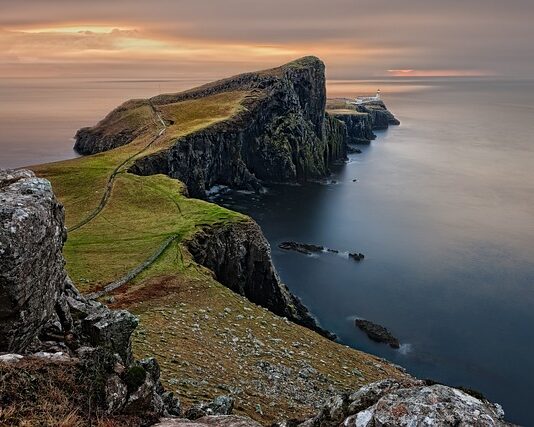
300, 380, 510, 427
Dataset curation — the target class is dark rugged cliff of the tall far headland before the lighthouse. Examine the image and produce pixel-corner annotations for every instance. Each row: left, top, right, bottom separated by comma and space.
75, 57, 347, 197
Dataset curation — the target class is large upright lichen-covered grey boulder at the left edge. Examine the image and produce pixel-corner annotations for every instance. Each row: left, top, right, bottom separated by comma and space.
0, 170, 66, 353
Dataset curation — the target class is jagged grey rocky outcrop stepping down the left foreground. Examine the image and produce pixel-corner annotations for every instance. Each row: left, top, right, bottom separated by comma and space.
0, 170, 177, 418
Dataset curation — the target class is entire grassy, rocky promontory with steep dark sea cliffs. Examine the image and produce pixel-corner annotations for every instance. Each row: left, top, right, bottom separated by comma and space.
10, 57, 510, 426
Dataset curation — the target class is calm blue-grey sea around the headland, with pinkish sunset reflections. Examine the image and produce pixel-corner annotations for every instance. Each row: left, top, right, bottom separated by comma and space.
0, 79, 534, 425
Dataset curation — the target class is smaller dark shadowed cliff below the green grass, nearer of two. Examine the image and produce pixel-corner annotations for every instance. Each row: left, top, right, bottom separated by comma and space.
186, 220, 334, 338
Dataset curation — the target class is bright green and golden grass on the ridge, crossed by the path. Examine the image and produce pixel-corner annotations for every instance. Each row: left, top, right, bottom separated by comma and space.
33, 92, 247, 292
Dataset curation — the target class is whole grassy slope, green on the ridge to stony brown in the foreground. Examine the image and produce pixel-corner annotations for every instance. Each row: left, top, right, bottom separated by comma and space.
33, 83, 408, 423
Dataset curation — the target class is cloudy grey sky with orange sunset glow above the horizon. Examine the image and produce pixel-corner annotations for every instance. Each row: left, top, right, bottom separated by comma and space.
0, 0, 534, 80
